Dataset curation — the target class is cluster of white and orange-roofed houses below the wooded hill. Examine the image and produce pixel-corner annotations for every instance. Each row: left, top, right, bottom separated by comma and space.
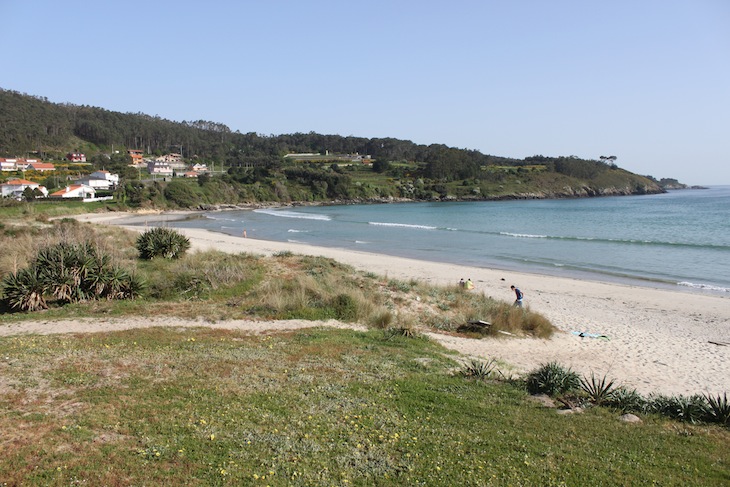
0, 149, 209, 202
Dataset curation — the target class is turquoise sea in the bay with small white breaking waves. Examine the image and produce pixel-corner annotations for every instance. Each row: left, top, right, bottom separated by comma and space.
154, 186, 730, 294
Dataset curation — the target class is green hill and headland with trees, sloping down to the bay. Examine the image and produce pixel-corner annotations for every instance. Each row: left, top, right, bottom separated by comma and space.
0, 88, 663, 205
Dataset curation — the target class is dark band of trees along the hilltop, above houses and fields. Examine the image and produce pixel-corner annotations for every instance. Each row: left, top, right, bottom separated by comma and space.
0, 89, 615, 180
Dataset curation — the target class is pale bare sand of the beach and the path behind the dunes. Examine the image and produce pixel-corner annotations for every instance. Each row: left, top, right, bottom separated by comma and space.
5, 213, 730, 395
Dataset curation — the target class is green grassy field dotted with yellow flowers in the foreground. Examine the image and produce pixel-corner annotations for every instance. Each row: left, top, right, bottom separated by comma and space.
0, 328, 730, 486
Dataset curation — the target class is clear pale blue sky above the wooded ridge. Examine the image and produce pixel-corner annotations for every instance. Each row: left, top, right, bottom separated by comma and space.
0, 0, 730, 184
